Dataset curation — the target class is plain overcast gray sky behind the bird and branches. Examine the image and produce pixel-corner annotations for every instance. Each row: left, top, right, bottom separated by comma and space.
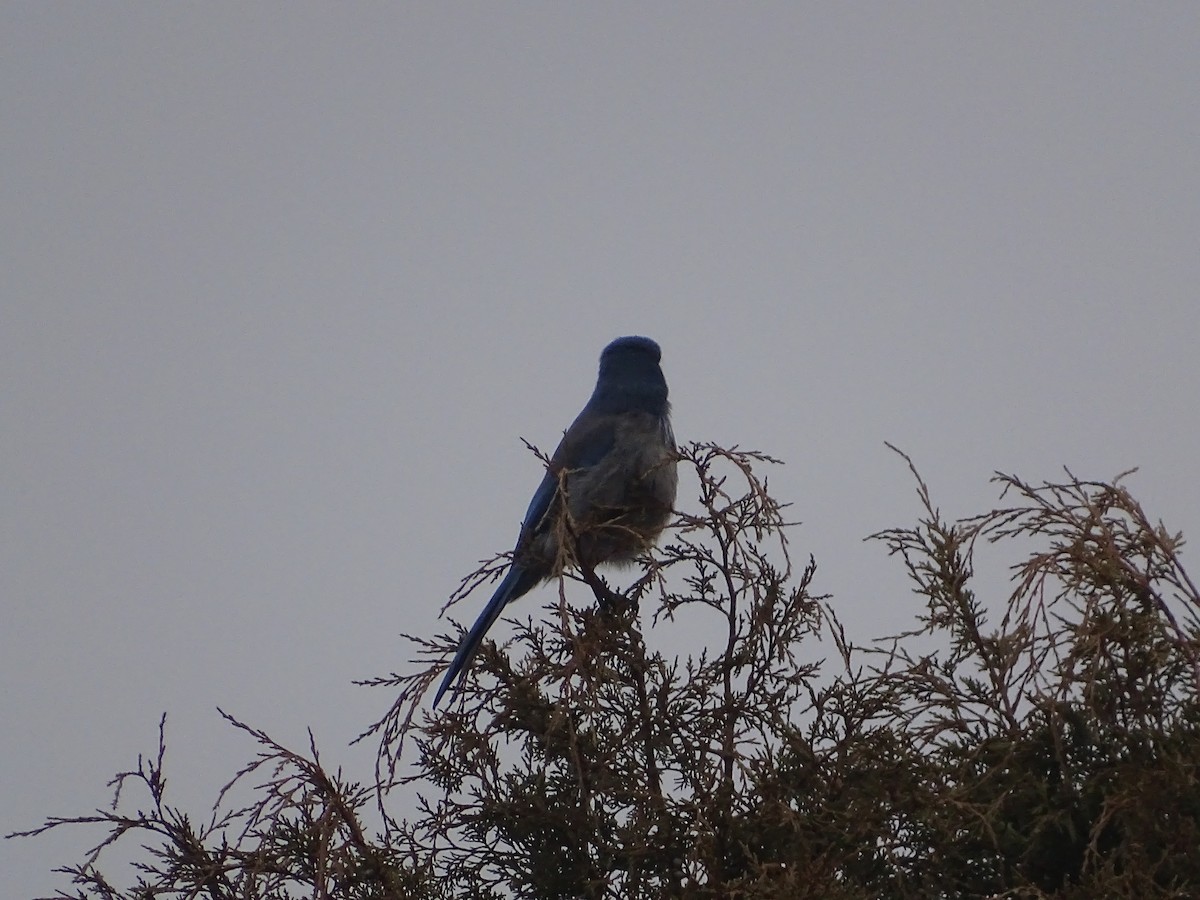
0, 2, 1200, 896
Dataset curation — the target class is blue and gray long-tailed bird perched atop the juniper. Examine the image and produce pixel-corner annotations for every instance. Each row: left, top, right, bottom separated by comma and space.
433, 336, 678, 708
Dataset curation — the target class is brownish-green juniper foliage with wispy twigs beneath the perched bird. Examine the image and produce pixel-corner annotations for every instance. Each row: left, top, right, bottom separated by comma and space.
11, 445, 1200, 900
